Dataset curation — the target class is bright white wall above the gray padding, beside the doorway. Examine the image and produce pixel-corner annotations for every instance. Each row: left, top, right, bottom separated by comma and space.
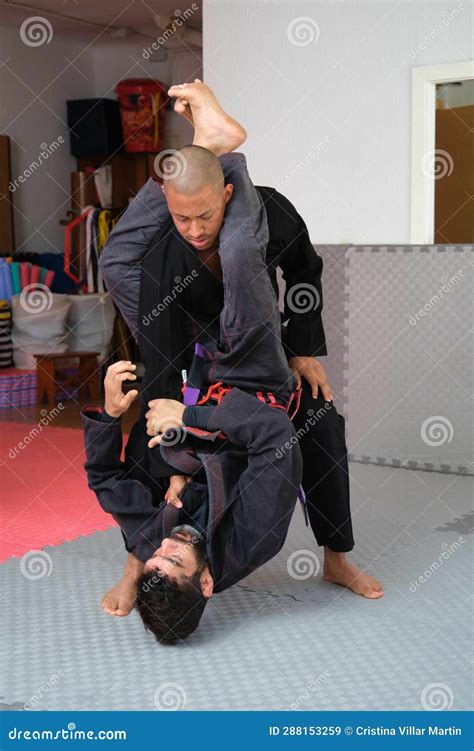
203, 0, 473, 243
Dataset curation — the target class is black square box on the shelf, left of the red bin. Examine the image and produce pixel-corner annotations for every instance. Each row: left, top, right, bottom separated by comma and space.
66, 99, 123, 157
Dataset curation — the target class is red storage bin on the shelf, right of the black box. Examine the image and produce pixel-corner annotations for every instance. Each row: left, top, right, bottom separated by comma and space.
115, 78, 168, 152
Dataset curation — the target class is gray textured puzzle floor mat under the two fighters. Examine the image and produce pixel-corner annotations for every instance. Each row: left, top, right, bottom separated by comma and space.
0, 463, 472, 710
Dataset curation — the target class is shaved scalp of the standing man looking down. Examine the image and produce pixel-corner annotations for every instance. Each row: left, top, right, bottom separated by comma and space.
163, 146, 224, 196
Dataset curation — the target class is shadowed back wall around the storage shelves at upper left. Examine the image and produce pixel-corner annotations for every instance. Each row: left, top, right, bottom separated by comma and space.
0, 26, 202, 253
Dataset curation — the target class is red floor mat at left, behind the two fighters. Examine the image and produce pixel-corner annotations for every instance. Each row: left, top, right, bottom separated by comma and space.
0, 422, 116, 561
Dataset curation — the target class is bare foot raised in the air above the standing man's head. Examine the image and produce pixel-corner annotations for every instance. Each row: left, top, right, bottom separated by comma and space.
168, 78, 247, 156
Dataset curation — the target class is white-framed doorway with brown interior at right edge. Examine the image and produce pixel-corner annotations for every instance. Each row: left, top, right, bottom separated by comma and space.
411, 61, 474, 245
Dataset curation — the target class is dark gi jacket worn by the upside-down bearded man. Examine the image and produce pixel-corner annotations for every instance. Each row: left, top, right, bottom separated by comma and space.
82, 389, 302, 592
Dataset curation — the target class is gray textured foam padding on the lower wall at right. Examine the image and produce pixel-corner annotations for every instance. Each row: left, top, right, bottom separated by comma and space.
315, 245, 474, 474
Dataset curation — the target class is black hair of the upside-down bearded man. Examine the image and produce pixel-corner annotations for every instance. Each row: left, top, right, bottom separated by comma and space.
136, 569, 207, 644
